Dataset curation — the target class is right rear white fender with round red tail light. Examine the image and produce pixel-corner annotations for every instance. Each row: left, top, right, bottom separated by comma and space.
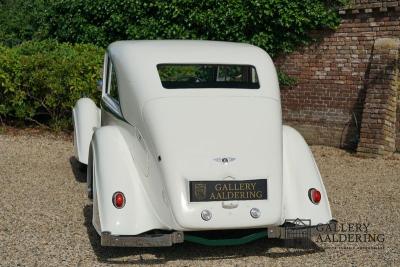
282, 126, 332, 225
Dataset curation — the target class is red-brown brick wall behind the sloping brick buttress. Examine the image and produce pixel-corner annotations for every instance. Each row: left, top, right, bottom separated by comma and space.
276, 0, 400, 153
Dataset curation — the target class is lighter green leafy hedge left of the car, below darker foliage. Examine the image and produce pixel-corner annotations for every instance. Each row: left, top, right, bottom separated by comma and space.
0, 41, 104, 129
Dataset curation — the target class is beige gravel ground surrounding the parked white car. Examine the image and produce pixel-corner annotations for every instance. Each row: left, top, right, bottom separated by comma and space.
0, 133, 400, 266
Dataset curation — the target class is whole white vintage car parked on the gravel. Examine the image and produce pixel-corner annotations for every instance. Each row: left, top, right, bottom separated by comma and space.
73, 40, 336, 247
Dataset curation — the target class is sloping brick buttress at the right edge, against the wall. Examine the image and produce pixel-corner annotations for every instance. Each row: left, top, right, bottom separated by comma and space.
357, 38, 400, 157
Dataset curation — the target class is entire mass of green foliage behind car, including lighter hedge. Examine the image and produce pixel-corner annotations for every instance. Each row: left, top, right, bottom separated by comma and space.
0, 0, 347, 129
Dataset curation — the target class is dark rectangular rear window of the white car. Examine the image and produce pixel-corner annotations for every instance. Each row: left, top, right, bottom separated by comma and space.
157, 64, 260, 89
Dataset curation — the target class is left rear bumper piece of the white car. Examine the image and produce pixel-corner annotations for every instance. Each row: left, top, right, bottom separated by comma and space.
101, 232, 184, 247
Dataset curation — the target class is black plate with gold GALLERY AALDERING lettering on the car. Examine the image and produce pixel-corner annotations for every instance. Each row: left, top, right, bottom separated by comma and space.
189, 179, 267, 202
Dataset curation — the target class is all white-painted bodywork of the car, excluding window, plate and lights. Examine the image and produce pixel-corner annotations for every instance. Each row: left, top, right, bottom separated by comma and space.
73, 41, 332, 241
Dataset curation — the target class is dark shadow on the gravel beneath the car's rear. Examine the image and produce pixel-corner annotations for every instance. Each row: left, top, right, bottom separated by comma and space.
83, 205, 324, 265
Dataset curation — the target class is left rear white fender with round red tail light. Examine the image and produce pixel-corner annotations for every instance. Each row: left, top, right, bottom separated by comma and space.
92, 126, 166, 235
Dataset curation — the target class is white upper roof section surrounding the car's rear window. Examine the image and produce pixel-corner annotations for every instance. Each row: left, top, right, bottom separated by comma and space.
107, 40, 280, 117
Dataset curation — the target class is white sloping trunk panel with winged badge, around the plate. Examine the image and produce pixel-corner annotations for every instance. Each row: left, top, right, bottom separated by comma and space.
143, 97, 282, 229
